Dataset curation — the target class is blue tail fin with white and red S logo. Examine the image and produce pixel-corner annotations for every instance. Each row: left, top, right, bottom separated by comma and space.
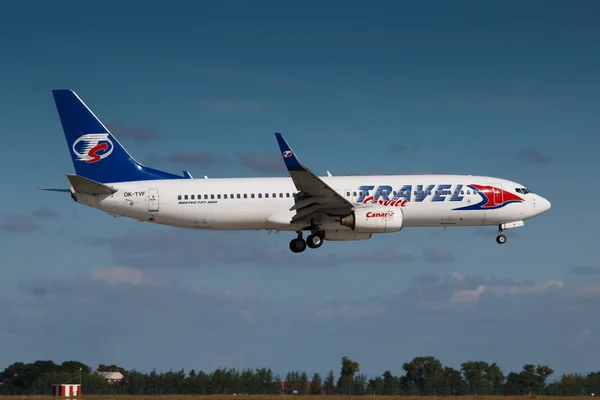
52, 90, 185, 183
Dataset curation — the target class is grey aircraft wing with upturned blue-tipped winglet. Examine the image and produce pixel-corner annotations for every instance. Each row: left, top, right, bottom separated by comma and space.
275, 132, 354, 222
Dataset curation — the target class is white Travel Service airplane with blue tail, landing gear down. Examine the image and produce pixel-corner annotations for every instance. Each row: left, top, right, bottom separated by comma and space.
43, 89, 551, 253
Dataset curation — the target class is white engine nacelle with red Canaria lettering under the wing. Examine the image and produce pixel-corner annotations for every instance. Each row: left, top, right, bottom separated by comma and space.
340, 206, 404, 233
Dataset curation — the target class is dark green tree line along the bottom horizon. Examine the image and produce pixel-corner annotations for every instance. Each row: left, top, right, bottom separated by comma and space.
0, 356, 600, 396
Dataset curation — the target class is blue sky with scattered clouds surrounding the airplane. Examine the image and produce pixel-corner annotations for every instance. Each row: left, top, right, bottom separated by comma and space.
0, 1, 600, 382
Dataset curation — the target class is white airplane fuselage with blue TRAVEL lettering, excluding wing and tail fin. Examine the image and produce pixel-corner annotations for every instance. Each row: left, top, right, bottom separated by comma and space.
70, 175, 550, 231
